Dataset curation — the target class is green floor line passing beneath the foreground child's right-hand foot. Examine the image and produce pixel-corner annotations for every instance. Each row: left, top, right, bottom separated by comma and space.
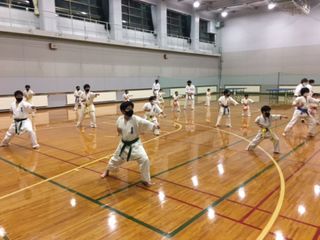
96, 122, 287, 201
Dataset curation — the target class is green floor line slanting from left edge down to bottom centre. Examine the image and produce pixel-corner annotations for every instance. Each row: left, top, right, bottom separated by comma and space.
0, 157, 168, 236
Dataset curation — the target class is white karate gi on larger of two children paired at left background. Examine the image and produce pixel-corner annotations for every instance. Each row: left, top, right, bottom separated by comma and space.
77, 92, 97, 128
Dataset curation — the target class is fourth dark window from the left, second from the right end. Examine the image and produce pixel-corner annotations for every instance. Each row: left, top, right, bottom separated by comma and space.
167, 10, 191, 37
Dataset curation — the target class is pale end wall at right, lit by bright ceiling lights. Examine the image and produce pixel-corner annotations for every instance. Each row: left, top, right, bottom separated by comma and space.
222, 6, 320, 91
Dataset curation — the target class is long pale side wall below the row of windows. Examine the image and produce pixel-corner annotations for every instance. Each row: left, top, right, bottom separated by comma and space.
0, 34, 219, 95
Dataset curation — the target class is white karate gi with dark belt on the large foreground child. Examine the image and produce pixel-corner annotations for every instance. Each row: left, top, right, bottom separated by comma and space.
107, 115, 155, 183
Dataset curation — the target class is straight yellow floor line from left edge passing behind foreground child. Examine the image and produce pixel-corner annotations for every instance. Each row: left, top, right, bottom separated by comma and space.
0, 123, 182, 200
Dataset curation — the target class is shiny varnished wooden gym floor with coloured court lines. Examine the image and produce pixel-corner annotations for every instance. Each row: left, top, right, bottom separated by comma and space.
0, 96, 320, 240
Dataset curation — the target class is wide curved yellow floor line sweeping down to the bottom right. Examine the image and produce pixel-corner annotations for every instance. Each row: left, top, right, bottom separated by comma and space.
195, 123, 286, 240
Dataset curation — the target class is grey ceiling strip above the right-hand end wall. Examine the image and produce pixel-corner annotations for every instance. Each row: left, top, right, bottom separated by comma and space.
175, 0, 320, 14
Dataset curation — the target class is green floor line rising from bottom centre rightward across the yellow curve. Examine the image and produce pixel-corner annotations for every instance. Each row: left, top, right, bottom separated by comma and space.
168, 140, 309, 238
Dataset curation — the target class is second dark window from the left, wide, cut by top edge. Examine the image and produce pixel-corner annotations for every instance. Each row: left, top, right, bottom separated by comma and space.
55, 0, 105, 21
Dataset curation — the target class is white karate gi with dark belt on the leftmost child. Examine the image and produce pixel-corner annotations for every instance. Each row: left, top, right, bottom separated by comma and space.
1, 101, 39, 148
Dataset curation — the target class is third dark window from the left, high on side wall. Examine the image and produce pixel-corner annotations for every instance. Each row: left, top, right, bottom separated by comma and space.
122, 0, 154, 31
